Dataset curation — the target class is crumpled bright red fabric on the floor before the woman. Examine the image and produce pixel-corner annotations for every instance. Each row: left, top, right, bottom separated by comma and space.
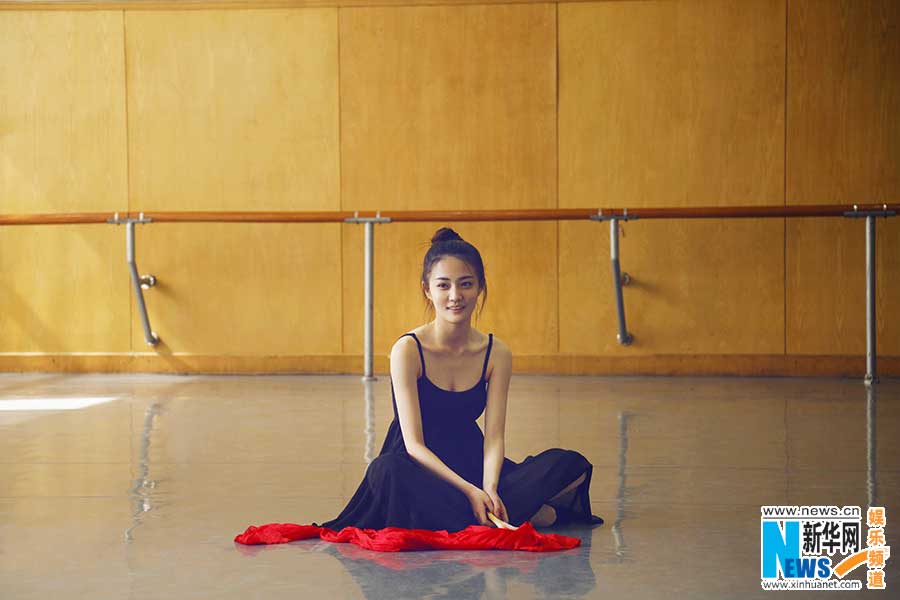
234, 522, 581, 552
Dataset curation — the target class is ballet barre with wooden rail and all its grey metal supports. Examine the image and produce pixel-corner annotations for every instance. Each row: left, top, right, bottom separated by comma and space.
0, 204, 900, 386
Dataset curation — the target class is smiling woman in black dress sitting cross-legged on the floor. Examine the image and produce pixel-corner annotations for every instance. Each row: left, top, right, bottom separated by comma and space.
322, 228, 603, 532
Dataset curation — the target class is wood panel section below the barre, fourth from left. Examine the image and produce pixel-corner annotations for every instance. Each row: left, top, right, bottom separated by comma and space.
559, 220, 784, 356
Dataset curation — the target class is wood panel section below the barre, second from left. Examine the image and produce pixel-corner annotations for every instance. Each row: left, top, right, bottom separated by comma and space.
132, 223, 341, 354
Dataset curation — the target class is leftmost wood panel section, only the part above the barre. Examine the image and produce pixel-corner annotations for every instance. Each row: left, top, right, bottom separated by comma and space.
0, 12, 127, 213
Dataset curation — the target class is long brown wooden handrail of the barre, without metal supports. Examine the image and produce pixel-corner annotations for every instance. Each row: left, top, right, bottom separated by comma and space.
0, 204, 900, 225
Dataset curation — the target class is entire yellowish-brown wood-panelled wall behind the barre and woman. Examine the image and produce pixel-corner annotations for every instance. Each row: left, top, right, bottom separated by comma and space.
0, 0, 900, 374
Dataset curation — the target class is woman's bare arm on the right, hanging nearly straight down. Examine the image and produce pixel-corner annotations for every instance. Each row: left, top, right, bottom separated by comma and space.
483, 338, 512, 493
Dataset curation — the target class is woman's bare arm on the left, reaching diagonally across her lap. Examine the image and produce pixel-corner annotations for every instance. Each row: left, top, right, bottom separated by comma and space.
391, 337, 477, 496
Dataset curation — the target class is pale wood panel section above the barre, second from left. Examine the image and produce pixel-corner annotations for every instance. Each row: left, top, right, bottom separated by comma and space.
126, 9, 340, 211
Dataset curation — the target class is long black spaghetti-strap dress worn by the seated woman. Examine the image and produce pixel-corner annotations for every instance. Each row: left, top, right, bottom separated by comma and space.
314, 333, 603, 532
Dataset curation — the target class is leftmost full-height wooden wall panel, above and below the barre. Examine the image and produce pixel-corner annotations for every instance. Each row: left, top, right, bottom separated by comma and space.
0, 12, 129, 353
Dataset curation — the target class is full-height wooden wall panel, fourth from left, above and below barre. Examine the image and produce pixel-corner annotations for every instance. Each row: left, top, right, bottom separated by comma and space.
559, 1, 785, 355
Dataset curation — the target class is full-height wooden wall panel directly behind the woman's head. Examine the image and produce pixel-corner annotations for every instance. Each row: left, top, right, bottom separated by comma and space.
341, 4, 558, 354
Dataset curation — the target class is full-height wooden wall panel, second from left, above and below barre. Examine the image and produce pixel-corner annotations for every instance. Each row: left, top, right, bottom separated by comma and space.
126, 9, 341, 356
